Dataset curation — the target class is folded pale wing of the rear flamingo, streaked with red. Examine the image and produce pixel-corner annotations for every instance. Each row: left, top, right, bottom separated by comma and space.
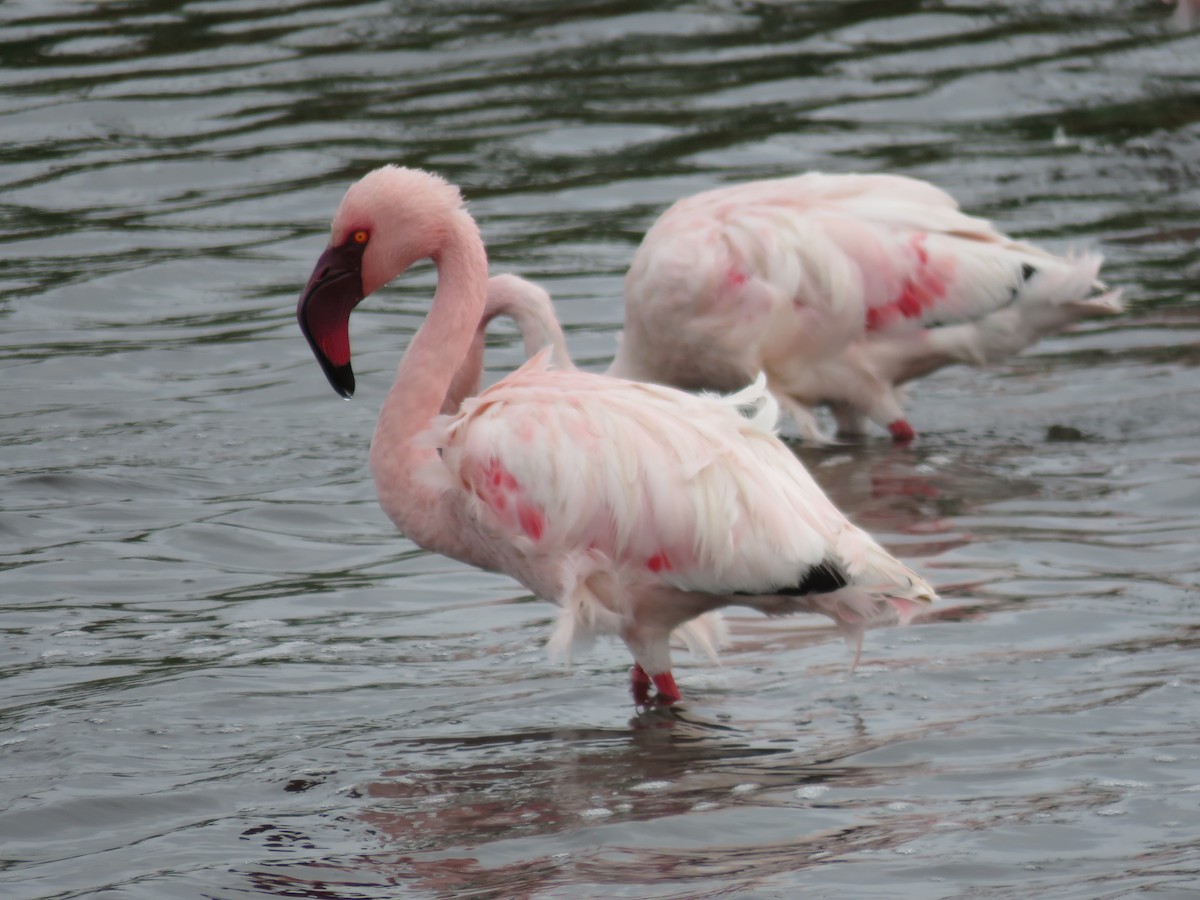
626, 173, 1087, 350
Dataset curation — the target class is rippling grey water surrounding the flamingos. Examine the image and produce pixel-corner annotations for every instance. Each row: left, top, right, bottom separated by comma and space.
0, 0, 1200, 900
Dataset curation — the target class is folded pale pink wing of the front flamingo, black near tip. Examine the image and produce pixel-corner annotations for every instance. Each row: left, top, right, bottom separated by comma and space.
436, 354, 931, 596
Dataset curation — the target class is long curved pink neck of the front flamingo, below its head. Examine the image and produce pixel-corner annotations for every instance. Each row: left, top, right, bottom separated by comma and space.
371, 212, 487, 556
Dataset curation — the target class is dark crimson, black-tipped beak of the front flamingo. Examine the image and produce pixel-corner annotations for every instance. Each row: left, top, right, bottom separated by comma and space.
296, 242, 362, 398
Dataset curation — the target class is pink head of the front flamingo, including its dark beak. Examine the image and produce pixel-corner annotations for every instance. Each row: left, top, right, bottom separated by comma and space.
296, 166, 462, 397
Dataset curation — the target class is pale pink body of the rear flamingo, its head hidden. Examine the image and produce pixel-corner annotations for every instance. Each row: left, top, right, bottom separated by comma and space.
610, 173, 1122, 442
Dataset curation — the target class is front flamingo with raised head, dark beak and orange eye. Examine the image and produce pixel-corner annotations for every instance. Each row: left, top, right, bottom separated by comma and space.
296, 166, 935, 704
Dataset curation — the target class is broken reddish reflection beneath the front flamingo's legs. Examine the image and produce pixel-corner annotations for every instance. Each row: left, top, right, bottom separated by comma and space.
241, 709, 926, 896
